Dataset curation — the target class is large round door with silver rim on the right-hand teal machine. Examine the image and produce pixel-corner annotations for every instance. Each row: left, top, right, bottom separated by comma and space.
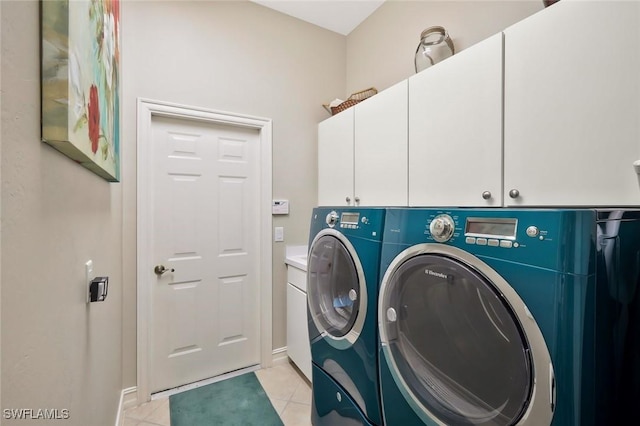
379, 244, 554, 425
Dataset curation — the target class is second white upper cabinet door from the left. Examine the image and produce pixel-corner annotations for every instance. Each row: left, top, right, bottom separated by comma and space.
354, 80, 408, 206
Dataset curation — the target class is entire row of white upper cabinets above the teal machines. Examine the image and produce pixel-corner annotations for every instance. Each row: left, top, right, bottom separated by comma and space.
318, 0, 640, 207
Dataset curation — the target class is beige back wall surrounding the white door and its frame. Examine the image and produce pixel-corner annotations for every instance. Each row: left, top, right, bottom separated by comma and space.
122, 1, 346, 387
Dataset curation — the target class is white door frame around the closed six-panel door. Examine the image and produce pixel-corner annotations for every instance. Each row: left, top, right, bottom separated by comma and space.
136, 98, 273, 404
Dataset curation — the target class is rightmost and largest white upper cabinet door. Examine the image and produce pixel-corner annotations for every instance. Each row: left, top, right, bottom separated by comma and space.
504, 1, 640, 206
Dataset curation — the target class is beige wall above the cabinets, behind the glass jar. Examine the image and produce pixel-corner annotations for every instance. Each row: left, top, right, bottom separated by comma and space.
344, 0, 540, 97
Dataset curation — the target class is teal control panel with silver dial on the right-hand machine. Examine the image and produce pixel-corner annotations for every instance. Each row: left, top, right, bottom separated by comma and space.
384, 207, 597, 273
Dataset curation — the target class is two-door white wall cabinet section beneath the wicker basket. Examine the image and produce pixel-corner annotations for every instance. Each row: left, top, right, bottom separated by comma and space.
318, 80, 407, 206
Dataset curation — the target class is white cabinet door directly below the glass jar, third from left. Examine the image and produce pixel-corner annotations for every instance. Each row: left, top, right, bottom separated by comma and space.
409, 33, 503, 206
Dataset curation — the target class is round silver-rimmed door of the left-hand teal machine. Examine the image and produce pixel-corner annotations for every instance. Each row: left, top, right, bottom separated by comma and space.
307, 229, 367, 349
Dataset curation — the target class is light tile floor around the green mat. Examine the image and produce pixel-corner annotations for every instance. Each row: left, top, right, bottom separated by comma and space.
122, 362, 311, 426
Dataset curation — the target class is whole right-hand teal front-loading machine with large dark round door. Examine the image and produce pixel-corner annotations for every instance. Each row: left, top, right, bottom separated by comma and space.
378, 208, 640, 426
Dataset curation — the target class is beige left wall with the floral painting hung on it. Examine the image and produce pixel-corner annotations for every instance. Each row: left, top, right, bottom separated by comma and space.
0, 1, 122, 426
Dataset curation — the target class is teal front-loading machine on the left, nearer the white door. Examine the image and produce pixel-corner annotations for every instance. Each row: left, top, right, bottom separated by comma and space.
307, 207, 386, 426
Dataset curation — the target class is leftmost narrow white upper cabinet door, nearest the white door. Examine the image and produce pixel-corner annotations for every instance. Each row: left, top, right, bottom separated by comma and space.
318, 108, 354, 206
